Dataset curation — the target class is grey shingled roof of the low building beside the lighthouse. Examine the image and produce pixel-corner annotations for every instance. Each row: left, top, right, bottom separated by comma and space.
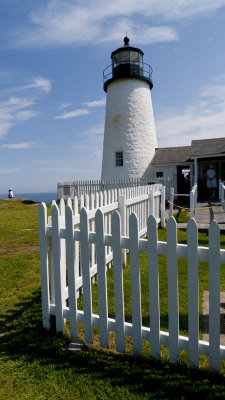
151, 138, 225, 164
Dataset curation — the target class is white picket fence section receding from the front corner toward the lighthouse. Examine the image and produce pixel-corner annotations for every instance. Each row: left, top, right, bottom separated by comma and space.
39, 185, 165, 303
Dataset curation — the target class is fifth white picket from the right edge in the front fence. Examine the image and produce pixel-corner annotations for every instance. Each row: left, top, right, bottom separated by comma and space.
129, 213, 142, 355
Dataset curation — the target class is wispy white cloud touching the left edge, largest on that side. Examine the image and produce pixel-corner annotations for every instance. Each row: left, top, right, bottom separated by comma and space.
0, 97, 38, 138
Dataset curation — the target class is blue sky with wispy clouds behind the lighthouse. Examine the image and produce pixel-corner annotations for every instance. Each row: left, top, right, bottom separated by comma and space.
0, 0, 225, 193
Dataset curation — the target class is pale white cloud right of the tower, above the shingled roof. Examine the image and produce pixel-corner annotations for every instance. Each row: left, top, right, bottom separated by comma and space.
156, 76, 225, 147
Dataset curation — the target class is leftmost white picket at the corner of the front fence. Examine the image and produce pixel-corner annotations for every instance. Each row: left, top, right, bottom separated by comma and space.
38, 203, 50, 330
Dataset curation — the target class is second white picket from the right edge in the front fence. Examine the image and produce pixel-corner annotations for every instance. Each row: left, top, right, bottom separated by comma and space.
187, 219, 199, 367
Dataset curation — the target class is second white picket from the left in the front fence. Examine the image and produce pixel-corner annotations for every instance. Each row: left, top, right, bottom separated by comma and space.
52, 204, 65, 332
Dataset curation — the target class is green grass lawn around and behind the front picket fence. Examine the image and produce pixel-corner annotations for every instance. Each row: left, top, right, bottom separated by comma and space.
0, 200, 225, 400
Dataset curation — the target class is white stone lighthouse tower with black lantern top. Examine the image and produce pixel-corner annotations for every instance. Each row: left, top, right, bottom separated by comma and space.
101, 37, 157, 180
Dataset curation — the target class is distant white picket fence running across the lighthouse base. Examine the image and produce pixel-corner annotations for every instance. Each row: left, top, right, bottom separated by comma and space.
57, 177, 172, 200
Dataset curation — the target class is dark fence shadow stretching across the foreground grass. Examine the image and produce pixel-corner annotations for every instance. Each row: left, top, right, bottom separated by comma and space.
0, 291, 225, 399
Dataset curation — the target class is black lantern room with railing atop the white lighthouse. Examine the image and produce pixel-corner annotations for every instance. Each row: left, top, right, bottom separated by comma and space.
103, 36, 153, 92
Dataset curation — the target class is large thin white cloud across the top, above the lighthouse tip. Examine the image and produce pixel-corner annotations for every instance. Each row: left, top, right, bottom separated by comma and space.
13, 0, 225, 46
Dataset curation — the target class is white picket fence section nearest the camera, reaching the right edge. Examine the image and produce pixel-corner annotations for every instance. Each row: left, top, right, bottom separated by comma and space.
39, 187, 225, 369
